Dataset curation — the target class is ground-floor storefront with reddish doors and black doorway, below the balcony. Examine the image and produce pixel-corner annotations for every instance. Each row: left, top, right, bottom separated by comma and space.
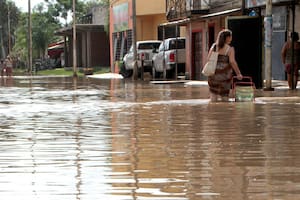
165, 0, 300, 83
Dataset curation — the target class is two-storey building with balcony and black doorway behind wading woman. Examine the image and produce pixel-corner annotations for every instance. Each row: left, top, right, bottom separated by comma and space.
164, 0, 300, 87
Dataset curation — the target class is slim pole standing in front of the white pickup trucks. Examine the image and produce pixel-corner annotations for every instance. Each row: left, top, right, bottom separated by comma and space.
132, 0, 138, 80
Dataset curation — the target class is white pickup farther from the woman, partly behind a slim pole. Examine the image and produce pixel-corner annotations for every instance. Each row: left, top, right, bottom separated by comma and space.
120, 40, 162, 78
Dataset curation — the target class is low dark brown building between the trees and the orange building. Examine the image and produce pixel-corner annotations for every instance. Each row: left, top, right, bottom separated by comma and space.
56, 6, 110, 68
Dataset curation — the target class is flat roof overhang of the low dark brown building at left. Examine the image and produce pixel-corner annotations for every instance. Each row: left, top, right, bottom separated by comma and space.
55, 24, 105, 36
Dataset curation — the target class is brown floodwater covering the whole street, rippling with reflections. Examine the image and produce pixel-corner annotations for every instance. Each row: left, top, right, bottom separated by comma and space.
0, 77, 300, 200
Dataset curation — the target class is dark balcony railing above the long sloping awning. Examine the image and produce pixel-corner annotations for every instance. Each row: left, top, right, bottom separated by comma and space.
166, 0, 210, 21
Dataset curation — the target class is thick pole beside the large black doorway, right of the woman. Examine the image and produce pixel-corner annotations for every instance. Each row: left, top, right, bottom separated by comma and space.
264, 0, 274, 91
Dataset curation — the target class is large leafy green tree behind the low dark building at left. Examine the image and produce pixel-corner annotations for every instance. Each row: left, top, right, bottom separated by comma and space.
13, 0, 109, 67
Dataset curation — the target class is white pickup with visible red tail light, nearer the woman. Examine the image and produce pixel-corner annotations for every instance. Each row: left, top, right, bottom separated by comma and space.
152, 37, 186, 78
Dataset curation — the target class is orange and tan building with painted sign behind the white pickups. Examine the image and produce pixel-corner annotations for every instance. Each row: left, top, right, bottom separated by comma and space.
109, 0, 166, 72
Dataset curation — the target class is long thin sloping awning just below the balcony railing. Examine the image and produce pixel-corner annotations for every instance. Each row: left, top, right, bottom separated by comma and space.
160, 8, 242, 26
